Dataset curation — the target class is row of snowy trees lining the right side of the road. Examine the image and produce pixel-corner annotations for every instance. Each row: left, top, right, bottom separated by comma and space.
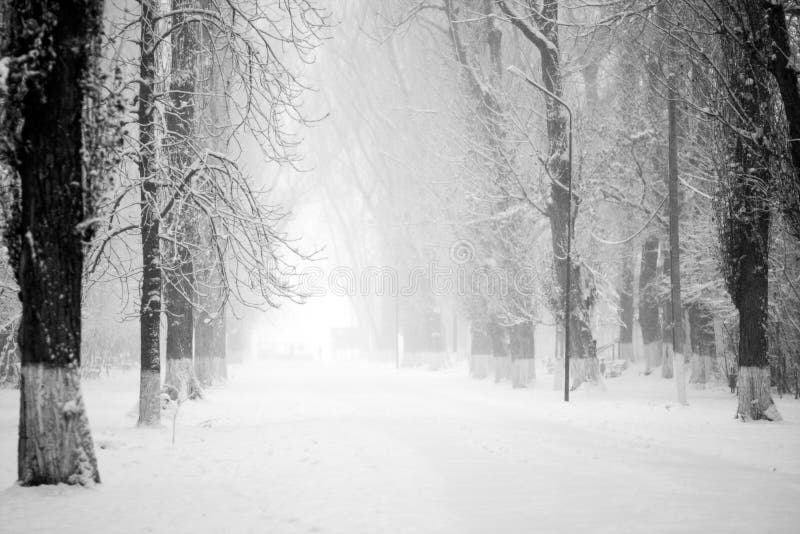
318, 0, 800, 419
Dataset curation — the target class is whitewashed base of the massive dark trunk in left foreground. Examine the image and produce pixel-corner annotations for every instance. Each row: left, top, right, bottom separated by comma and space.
18, 363, 100, 485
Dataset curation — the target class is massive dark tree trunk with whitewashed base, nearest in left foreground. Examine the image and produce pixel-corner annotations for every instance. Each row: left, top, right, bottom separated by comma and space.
2, 0, 102, 486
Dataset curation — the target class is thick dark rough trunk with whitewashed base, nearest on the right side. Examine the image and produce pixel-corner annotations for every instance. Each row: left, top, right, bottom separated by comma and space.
720, 2, 780, 421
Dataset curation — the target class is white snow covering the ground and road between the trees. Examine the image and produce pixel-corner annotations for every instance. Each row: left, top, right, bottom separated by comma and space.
0, 362, 800, 534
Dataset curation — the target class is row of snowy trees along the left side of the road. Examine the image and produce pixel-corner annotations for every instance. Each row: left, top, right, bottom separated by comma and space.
0, 0, 327, 485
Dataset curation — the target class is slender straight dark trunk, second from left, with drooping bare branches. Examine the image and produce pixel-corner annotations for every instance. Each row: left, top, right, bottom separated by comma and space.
138, 0, 161, 426
